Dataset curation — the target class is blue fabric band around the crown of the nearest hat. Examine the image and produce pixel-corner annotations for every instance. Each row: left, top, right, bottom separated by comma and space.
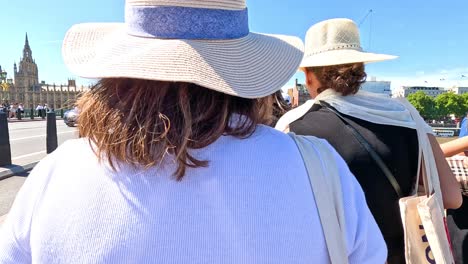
125, 6, 250, 40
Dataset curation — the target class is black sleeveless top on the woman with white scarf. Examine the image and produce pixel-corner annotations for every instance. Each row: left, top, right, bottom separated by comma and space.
289, 105, 418, 263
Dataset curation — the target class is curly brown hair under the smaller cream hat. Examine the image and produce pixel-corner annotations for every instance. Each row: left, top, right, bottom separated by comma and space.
306, 63, 367, 96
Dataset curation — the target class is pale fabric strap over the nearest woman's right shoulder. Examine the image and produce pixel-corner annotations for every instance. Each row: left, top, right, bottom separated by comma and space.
289, 133, 348, 264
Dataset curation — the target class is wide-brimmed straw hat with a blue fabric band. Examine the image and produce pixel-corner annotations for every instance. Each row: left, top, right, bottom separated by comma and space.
63, 0, 303, 98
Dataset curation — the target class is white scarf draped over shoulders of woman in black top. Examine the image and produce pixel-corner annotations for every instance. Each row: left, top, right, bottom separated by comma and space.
276, 89, 432, 133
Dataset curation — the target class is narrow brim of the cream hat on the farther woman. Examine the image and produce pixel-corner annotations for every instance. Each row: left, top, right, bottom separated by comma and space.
300, 49, 398, 68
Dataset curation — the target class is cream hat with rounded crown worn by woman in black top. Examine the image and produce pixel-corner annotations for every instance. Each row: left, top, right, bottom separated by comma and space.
301, 18, 397, 68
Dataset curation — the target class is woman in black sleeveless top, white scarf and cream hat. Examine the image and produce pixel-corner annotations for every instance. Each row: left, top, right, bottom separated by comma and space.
276, 19, 461, 263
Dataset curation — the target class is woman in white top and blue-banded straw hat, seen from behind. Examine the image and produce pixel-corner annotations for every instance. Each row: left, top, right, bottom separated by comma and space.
0, 3, 386, 263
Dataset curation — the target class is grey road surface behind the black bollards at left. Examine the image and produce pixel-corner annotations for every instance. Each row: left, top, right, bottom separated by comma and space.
8, 120, 78, 165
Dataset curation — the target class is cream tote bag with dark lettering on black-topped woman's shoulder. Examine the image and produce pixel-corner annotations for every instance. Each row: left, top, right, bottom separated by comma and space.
400, 99, 454, 264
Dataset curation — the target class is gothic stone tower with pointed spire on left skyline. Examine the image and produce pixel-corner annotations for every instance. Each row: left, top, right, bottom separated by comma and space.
14, 33, 39, 95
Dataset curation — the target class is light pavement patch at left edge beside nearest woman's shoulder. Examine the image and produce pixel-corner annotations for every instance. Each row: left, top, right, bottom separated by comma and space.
0, 173, 29, 217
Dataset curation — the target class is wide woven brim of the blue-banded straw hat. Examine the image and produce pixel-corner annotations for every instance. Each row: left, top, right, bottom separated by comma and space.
63, 23, 303, 98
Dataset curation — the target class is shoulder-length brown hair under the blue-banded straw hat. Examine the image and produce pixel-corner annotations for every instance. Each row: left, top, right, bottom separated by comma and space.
77, 78, 273, 180
